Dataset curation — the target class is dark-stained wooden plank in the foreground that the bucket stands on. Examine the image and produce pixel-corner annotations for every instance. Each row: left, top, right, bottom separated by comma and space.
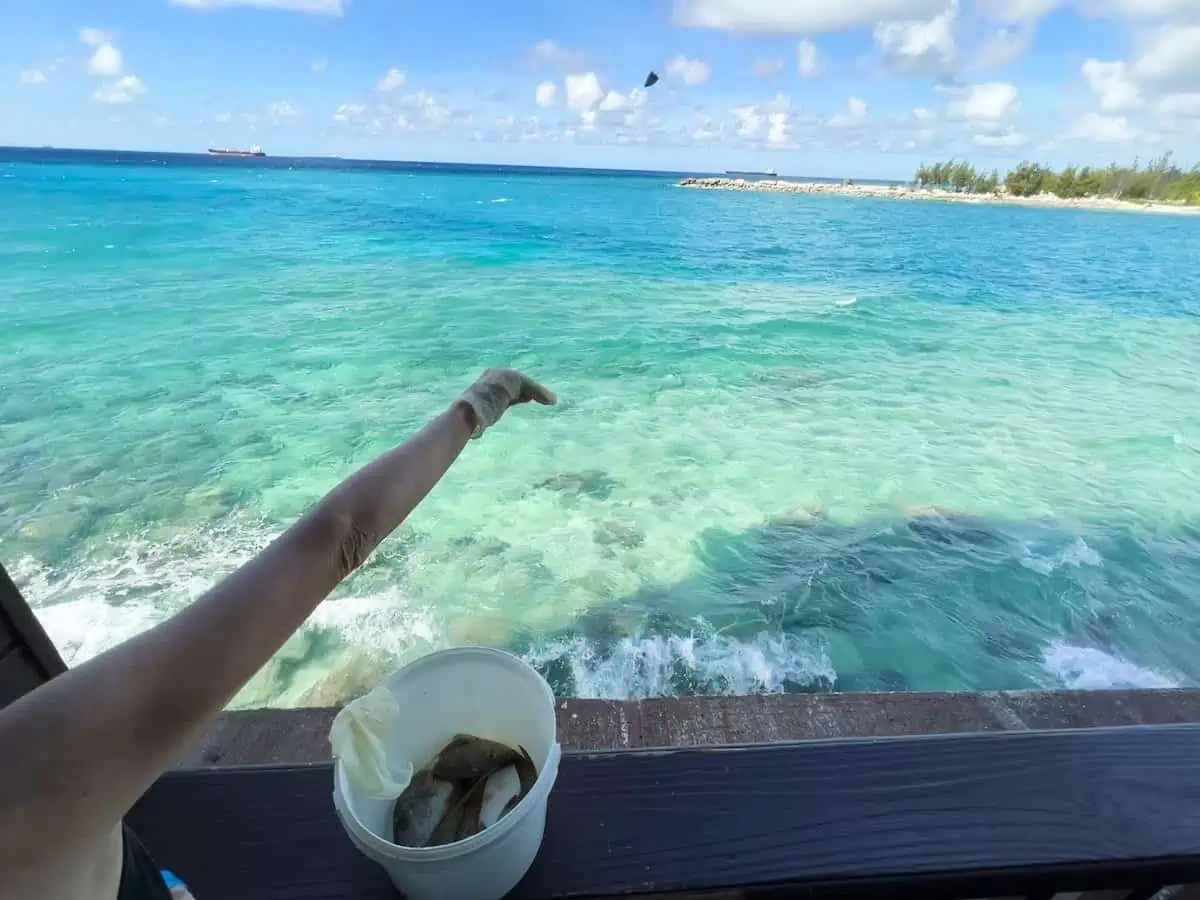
131, 725, 1200, 900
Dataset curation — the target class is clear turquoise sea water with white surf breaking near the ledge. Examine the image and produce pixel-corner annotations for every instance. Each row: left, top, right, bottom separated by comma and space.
0, 155, 1200, 706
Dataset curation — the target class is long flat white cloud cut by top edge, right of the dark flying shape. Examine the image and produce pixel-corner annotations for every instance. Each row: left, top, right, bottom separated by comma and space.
674, 0, 946, 34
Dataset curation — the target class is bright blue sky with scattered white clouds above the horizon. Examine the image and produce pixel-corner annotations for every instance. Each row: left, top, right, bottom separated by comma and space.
0, 0, 1200, 178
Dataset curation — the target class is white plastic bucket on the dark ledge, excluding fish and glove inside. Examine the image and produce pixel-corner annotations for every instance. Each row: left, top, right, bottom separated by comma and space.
334, 647, 560, 900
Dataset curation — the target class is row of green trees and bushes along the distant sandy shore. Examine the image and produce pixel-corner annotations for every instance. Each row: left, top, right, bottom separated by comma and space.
916, 152, 1200, 205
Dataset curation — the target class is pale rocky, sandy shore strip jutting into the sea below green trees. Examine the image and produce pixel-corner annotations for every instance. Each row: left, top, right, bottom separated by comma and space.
677, 178, 1200, 216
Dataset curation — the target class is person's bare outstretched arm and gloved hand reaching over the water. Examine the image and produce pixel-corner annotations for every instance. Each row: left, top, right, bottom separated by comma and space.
0, 370, 554, 900
